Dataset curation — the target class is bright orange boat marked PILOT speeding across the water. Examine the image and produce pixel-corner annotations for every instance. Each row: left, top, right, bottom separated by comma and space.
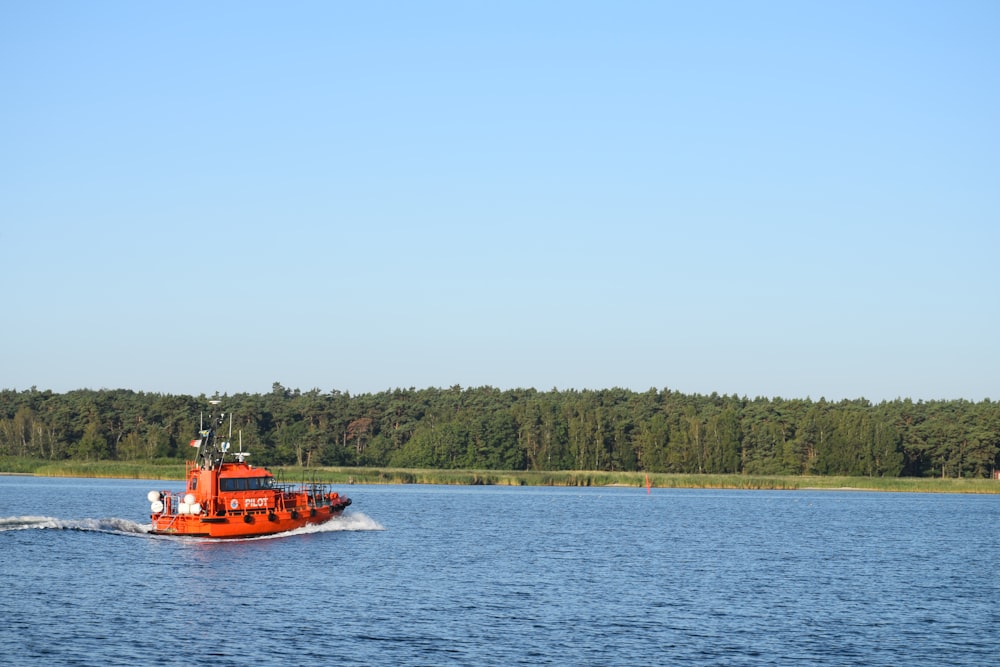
148, 414, 351, 538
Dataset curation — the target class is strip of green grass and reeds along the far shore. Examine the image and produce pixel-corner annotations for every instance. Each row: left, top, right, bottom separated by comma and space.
0, 457, 1000, 493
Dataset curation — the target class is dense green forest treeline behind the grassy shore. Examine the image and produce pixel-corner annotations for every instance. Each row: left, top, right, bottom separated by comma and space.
0, 383, 1000, 477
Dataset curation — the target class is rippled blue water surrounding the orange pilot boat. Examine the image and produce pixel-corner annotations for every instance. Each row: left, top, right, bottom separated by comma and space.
0, 477, 1000, 667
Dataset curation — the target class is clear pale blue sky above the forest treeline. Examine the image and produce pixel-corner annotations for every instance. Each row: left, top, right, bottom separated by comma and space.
0, 0, 1000, 401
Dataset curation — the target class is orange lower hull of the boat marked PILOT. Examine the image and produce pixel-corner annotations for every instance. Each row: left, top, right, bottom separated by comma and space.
150, 506, 344, 539
